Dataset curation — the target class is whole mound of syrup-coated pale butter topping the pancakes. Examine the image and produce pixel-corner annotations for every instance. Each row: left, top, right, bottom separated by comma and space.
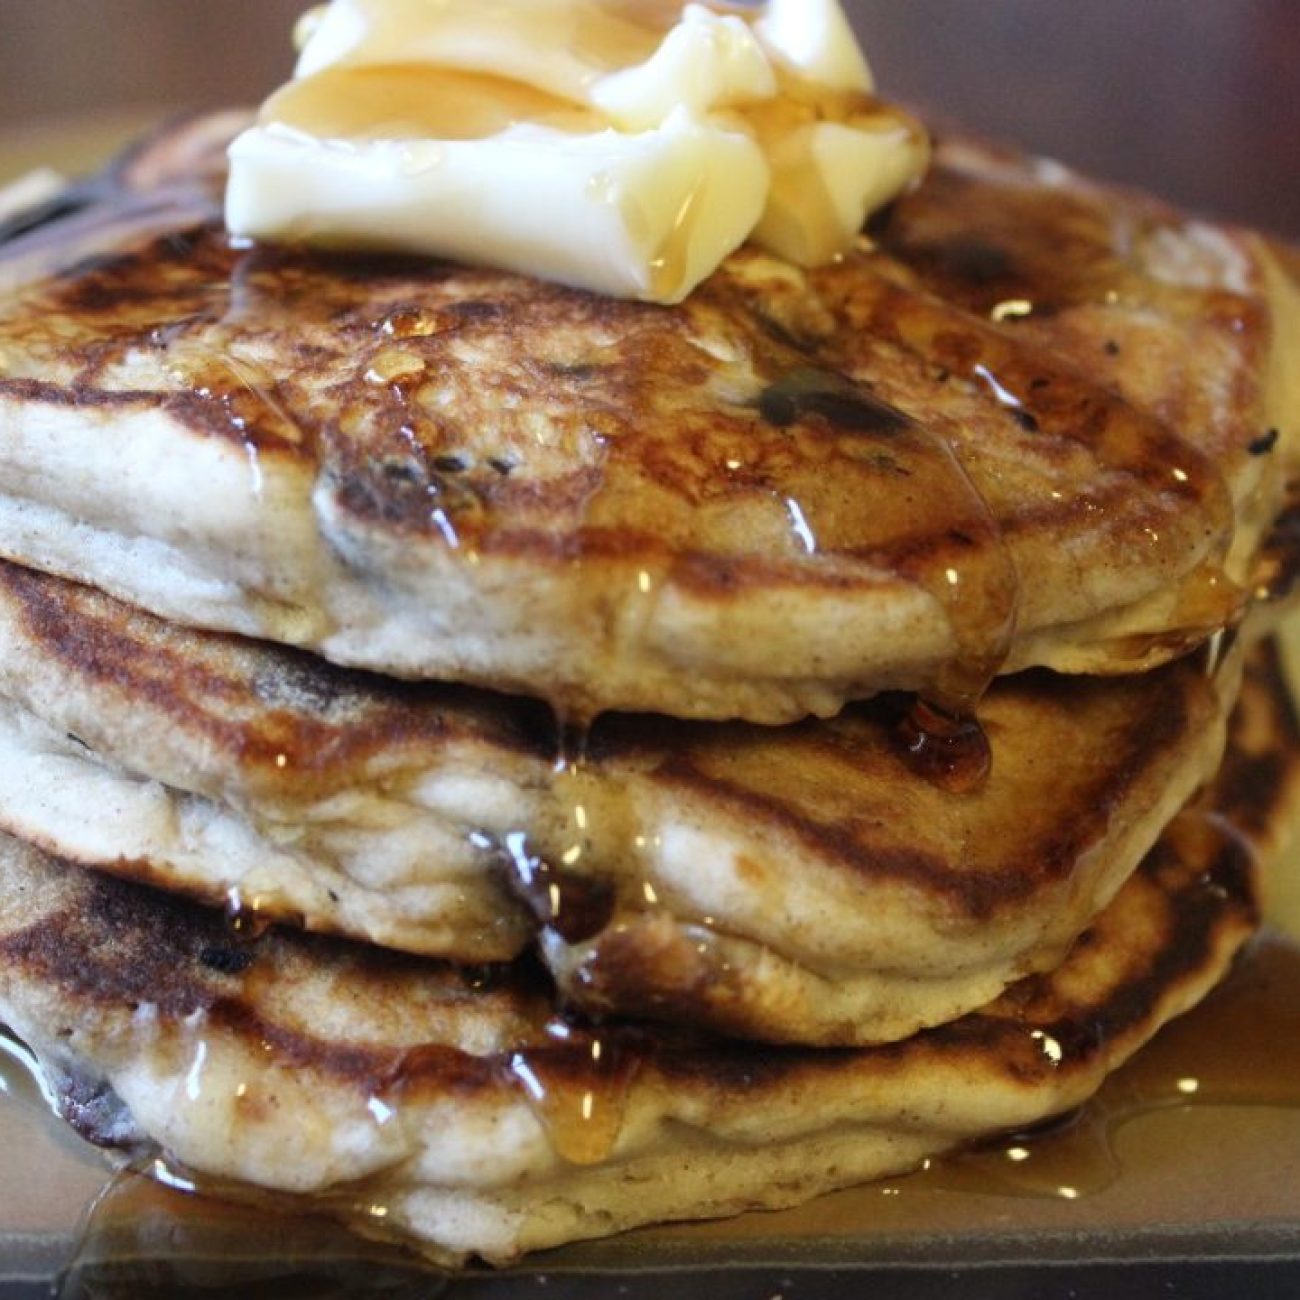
226, 0, 928, 303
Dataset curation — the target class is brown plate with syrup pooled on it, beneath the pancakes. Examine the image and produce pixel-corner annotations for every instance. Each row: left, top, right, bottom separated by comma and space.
0, 931, 1300, 1300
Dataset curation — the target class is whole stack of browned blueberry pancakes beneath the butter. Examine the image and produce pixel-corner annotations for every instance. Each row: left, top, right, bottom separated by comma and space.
0, 118, 1300, 1261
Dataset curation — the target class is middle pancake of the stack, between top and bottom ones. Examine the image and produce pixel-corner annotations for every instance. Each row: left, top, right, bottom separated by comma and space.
0, 563, 1240, 1044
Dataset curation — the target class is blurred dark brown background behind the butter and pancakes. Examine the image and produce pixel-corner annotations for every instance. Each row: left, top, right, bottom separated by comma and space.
0, 0, 1300, 237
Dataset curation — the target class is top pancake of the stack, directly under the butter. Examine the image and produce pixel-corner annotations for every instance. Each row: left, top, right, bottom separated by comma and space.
0, 119, 1300, 723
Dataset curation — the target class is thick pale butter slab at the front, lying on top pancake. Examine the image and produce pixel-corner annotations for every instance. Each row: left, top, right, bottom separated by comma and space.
228, 113, 767, 302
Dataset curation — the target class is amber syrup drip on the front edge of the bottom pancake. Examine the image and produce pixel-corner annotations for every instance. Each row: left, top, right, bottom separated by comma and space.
507, 1019, 640, 1165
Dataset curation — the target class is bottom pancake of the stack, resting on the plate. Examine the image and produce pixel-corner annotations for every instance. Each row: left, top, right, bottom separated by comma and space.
0, 644, 1300, 1261
